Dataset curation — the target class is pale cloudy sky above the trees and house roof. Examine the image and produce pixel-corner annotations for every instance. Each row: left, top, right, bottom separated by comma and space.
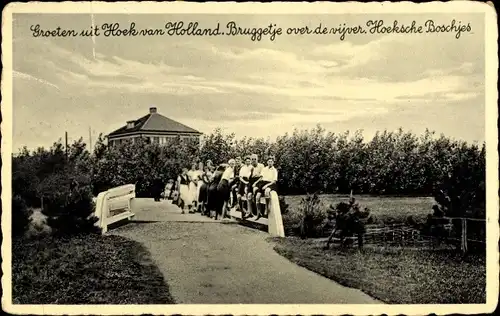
9, 14, 485, 152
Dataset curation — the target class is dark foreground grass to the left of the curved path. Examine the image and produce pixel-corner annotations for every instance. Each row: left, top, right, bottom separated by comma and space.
12, 235, 174, 304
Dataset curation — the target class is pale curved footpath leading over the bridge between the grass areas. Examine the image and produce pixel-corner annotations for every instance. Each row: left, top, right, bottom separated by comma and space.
109, 199, 381, 304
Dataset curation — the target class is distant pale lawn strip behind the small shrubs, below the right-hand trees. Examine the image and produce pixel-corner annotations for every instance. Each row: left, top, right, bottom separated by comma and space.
286, 194, 434, 222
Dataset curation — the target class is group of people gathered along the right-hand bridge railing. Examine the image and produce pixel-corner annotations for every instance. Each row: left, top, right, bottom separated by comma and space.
165, 154, 278, 219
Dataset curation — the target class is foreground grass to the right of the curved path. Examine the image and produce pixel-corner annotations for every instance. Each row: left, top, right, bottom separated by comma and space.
273, 238, 486, 304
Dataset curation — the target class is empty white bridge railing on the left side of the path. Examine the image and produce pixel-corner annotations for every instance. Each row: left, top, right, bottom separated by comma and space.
95, 184, 135, 234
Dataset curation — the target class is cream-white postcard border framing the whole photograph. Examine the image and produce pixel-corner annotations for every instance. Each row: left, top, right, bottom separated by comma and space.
1, 1, 499, 315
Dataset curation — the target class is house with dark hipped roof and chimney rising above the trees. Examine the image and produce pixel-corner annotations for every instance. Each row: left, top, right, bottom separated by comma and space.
107, 107, 203, 146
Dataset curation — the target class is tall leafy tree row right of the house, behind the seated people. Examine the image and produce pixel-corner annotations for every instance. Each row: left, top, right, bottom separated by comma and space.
200, 126, 486, 209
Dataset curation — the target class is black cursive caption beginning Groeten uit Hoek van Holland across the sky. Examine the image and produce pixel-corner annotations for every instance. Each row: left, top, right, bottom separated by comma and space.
30, 19, 472, 41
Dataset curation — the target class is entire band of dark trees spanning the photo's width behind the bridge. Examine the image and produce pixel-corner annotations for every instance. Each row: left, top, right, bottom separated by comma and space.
12, 126, 485, 237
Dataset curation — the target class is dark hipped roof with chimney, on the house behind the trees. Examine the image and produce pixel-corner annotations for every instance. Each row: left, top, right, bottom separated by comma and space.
108, 108, 202, 136
